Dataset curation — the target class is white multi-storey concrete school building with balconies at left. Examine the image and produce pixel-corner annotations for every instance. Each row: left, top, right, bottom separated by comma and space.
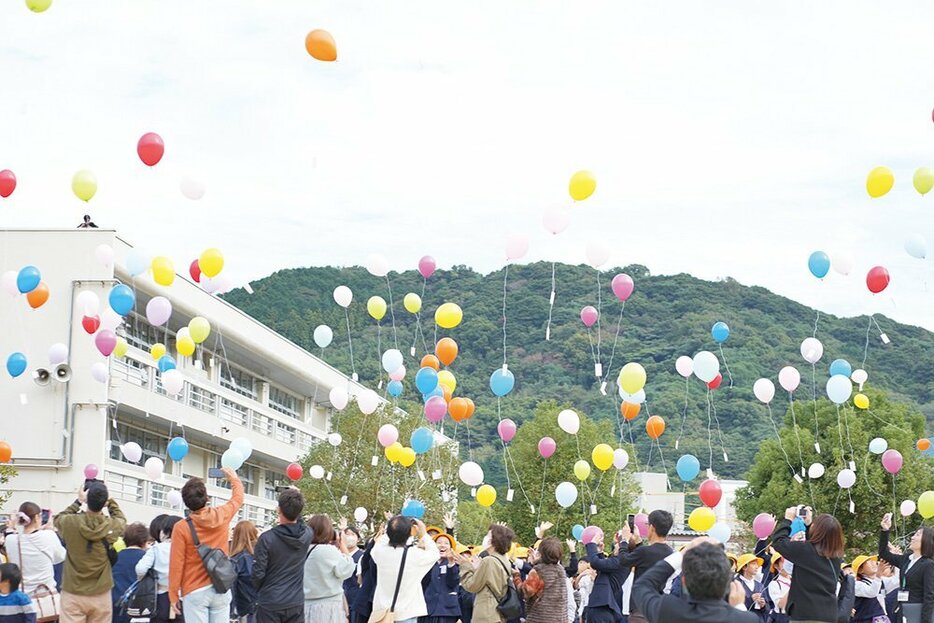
0, 230, 372, 526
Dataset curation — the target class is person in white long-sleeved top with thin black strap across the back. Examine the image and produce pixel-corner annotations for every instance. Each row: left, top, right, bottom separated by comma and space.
370, 515, 439, 623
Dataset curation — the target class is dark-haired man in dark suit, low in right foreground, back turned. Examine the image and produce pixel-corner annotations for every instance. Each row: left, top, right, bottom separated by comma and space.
632, 537, 758, 623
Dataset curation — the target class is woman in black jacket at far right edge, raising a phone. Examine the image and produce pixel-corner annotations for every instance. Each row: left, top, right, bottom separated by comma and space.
879, 513, 934, 623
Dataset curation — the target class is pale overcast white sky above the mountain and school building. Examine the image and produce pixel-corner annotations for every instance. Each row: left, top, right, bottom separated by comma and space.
0, 0, 934, 330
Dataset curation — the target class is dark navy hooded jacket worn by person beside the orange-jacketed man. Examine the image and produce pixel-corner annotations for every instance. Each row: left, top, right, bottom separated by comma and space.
253, 519, 312, 611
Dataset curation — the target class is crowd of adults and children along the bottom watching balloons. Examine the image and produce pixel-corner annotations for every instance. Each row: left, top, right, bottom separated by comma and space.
0, 470, 934, 623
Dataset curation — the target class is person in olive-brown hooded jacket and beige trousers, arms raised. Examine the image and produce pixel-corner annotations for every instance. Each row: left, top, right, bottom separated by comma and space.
55, 482, 126, 623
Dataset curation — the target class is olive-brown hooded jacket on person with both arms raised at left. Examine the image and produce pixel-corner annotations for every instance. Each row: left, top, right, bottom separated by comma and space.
55, 500, 126, 595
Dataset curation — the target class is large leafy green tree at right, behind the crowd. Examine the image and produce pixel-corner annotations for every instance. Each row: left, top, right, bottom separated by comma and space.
736, 391, 934, 553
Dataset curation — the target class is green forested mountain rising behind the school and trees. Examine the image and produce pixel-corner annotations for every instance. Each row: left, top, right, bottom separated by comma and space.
226, 263, 934, 482
